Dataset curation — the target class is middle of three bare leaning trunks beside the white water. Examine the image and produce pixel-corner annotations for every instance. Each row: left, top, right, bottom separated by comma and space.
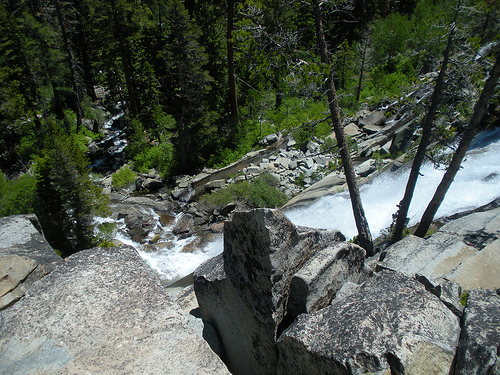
391, 1, 460, 243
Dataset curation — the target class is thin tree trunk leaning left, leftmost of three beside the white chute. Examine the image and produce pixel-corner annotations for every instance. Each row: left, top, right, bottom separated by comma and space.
312, 0, 373, 255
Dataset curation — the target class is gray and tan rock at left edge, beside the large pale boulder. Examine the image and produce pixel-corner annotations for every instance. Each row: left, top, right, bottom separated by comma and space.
0, 215, 63, 310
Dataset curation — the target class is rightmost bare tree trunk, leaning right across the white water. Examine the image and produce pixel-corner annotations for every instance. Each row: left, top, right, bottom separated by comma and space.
415, 52, 500, 237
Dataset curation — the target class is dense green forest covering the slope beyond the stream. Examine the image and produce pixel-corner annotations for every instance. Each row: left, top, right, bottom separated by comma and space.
0, 0, 500, 254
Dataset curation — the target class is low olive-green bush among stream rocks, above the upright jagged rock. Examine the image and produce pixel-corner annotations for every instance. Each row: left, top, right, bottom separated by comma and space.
200, 173, 287, 208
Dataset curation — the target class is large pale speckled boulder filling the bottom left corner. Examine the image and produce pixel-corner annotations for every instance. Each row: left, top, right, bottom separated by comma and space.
0, 246, 228, 375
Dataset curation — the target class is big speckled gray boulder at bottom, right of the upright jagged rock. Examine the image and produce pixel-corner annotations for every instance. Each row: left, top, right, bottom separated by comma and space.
278, 271, 460, 375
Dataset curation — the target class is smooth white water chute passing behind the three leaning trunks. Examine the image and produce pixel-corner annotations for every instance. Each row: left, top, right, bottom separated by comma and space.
285, 129, 500, 239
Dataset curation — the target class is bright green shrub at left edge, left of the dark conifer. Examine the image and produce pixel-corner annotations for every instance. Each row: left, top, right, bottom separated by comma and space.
0, 171, 36, 216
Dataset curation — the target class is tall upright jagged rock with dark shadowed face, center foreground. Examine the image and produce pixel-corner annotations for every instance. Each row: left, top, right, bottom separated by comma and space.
194, 209, 344, 374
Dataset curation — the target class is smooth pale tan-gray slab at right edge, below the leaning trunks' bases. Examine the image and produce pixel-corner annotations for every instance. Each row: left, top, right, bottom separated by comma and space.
377, 208, 500, 290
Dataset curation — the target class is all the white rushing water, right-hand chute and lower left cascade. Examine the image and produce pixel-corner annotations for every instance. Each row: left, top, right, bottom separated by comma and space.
100, 129, 500, 283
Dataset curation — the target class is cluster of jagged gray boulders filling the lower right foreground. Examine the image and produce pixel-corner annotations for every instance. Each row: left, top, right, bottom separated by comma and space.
194, 208, 500, 375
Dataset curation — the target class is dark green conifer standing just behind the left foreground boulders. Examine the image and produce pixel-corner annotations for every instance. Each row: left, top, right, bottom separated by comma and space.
35, 127, 109, 256
